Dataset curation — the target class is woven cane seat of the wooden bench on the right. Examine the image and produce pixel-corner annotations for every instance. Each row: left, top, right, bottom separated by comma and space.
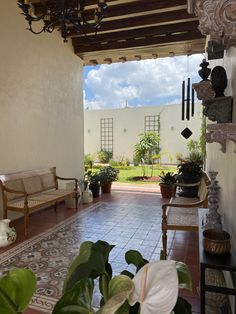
167, 207, 198, 230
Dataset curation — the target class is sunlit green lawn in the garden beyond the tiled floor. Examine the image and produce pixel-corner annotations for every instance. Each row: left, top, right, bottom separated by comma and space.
117, 166, 176, 184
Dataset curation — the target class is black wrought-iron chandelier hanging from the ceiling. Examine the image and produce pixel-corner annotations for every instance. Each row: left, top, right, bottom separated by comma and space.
18, 0, 107, 42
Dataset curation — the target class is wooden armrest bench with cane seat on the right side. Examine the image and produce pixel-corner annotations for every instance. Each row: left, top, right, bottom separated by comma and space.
162, 173, 210, 257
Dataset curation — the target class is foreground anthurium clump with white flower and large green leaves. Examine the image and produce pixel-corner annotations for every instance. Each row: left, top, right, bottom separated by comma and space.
0, 241, 192, 314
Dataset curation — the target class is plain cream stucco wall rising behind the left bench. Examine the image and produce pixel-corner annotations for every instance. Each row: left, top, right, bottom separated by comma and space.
0, 0, 83, 218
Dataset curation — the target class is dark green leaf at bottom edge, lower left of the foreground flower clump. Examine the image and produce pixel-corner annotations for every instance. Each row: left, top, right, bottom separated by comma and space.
52, 278, 94, 314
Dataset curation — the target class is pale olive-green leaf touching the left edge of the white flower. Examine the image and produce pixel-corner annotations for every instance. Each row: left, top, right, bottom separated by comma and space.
96, 275, 134, 314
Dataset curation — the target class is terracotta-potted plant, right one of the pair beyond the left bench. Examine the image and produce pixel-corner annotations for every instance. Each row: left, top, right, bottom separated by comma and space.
99, 166, 119, 193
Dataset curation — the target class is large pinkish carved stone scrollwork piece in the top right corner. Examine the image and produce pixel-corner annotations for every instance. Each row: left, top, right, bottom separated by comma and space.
194, 0, 236, 48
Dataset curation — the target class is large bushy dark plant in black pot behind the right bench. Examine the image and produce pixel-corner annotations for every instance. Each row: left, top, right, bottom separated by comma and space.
177, 159, 202, 197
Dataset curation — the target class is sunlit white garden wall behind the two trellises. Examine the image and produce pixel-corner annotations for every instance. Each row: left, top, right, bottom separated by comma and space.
84, 104, 202, 163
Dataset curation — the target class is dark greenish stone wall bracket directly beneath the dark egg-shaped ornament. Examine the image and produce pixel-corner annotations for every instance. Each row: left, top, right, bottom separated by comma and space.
202, 96, 233, 123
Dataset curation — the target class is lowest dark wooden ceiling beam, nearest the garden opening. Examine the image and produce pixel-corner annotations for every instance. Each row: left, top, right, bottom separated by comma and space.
72, 21, 198, 46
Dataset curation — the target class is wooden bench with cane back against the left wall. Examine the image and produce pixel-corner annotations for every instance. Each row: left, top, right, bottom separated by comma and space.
0, 167, 80, 236
